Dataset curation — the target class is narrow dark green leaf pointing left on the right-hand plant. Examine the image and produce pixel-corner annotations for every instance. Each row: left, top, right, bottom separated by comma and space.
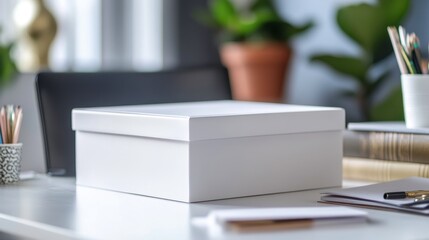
311, 55, 368, 83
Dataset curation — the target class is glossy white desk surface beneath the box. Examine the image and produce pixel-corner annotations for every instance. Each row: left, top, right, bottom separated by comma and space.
0, 176, 429, 240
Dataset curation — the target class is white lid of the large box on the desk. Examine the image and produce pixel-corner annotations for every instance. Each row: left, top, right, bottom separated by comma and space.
72, 100, 345, 141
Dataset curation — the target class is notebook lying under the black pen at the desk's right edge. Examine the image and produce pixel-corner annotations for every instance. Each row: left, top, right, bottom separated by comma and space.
321, 177, 429, 215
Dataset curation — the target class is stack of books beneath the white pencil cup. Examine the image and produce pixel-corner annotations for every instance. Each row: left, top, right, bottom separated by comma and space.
343, 122, 429, 181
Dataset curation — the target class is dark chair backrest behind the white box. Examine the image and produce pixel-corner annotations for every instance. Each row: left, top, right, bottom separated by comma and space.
36, 67, 231, 176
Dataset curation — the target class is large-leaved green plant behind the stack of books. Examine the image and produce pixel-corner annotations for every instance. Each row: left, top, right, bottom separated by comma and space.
311, 0, 410, 121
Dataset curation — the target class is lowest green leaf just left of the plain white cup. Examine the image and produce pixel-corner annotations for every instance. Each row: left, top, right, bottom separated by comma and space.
370, 87, 405, 121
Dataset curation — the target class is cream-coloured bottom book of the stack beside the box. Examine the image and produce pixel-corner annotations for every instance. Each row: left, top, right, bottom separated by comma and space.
343, 157, 429, 182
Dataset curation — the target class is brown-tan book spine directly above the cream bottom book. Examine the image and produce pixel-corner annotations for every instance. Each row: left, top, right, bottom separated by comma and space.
343, 130, 429, 164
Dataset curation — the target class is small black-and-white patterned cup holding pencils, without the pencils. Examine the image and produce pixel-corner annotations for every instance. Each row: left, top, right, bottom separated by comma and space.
0, 143, 22, 184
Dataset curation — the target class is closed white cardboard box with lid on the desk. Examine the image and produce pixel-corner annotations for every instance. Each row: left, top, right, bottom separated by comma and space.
72, 101, 345, 202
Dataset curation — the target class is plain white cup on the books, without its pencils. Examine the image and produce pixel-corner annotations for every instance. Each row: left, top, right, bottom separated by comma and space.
401, 74, 429, 128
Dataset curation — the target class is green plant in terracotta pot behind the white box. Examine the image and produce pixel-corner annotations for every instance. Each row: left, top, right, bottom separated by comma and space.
199, 0, 312, 102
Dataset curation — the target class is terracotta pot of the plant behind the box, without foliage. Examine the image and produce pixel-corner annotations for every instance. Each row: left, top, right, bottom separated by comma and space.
221, 43, 292, 102
